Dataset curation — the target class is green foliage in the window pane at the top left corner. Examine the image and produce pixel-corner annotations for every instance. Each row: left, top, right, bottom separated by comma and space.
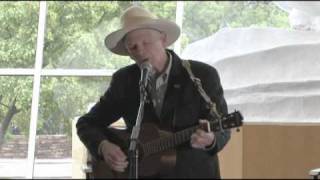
0, 2, 39, 68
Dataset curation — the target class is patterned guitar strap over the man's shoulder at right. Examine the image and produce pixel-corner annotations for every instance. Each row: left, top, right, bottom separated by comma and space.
182, 60, 222, 119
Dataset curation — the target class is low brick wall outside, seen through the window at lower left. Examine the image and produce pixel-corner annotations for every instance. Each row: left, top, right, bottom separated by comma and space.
0, 135, 72, 159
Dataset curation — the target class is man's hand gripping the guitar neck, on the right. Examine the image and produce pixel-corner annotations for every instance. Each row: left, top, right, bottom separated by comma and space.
190, 120, 215, 149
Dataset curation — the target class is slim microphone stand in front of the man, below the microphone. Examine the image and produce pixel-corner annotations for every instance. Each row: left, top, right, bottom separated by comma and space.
128, 82, 147, 179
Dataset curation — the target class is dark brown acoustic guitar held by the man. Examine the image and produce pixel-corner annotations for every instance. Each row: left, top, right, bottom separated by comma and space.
87, 111, 243, 178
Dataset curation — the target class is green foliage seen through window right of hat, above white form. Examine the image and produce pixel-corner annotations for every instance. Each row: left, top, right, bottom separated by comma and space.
181, 1, 289, 49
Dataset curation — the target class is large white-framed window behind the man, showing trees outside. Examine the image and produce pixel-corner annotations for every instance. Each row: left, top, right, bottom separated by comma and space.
0, 1, 288, 178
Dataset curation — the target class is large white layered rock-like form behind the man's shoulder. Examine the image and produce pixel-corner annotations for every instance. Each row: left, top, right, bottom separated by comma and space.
182, 28, 320, 122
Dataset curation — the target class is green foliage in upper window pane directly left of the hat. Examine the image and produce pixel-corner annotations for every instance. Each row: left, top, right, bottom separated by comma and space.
44, 1, 130, 69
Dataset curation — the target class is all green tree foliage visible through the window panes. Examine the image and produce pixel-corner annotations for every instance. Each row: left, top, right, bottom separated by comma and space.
0, 1, 289, 139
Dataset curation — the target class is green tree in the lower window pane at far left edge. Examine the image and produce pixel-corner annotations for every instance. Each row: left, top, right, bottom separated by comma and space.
0, 76, 32, 144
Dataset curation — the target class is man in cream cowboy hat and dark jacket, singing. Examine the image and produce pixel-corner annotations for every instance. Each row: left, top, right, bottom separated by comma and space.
77, 6, 230, 178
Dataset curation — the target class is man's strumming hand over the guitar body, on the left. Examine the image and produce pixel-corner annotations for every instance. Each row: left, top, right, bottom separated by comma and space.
101, 140, 128, 172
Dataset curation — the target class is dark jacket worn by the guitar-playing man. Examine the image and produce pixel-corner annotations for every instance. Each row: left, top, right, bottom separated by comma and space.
76, 50, 230, 178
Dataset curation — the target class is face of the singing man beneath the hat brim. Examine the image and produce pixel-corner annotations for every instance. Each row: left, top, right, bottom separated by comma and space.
124, 29, 165, 69
